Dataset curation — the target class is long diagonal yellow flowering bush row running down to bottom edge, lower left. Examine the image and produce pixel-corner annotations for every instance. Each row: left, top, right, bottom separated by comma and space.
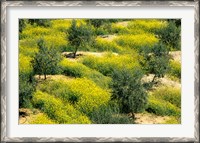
33, 91, 91, 124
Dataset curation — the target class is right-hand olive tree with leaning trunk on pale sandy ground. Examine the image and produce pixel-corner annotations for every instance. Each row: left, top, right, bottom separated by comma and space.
140, 43, 170, 83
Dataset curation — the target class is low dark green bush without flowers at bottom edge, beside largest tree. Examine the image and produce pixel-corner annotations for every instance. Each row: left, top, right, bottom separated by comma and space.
89, 104, 133, 124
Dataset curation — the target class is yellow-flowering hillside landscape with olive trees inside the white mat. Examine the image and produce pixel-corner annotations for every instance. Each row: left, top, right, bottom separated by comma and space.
19, 19, 181, 124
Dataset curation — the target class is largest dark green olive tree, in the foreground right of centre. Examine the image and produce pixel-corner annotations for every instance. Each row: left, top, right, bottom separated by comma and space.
112, 68, 147, 119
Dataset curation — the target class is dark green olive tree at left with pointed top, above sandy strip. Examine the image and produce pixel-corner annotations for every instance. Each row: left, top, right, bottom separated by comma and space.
32, 40, 61, 79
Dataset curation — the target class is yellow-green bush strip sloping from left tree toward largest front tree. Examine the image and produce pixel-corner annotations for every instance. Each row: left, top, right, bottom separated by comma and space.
60, 59, 111, 88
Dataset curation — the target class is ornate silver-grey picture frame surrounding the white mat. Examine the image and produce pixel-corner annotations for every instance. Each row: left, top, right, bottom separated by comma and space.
1, 1, 199, 142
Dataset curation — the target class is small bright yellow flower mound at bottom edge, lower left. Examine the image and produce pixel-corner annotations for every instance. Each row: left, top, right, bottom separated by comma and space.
30, 113, 56, 124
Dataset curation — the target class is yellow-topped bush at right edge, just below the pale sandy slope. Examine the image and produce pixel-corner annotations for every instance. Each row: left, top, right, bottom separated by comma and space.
152, 87, 181, 108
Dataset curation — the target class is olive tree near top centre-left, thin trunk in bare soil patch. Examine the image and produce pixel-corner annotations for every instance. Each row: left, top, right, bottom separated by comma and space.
68, 20, 93, 58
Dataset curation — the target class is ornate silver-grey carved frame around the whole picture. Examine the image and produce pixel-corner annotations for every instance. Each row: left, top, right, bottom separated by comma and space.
1, 0, 199, 142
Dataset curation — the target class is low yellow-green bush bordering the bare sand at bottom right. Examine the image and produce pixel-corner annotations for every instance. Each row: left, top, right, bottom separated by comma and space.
146, 97, 181, 116
